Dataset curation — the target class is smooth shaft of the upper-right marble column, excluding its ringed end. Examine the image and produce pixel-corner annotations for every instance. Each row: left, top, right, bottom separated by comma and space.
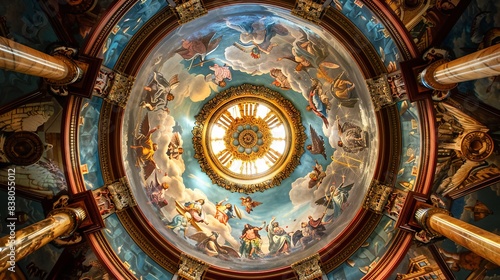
434, 44, 500, 84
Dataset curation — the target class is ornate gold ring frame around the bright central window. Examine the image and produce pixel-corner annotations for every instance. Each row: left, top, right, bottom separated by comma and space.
192, 84, 306, 193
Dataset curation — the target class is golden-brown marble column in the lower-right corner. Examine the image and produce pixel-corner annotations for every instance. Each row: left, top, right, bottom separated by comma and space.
415, 208, 500, 265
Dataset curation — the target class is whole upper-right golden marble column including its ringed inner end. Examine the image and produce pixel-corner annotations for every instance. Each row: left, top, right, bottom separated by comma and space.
419, 44, 500, 91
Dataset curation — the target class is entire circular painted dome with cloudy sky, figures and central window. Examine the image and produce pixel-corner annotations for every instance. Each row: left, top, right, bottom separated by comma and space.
122, 5, 378, 271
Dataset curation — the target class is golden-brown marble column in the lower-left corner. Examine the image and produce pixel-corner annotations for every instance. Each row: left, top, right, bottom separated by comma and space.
0, 208, 86, 272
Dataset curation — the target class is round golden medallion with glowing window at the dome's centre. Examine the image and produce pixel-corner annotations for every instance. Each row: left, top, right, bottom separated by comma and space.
193, 84, 306, 193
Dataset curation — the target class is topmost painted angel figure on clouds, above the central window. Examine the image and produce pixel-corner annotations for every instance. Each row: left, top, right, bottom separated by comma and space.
226, 18, 289, 59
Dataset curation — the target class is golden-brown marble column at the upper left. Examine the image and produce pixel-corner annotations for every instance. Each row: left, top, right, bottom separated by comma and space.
0, 36, 82, 85
